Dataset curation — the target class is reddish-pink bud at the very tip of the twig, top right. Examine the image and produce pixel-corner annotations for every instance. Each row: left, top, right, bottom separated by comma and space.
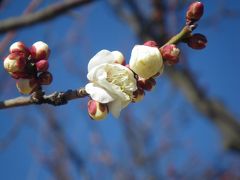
186, 1, 204, 22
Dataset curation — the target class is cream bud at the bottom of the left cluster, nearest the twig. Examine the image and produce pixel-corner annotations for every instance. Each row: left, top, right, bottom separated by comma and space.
16, 79, 39, 94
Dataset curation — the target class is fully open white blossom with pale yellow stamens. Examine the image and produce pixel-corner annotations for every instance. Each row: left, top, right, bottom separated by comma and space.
85, 50, 137, 117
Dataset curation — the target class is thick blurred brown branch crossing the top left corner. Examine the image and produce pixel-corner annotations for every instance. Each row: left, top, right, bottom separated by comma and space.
0, 0, 93, 33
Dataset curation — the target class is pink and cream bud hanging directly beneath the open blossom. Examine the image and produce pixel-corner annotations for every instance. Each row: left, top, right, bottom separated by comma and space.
88, 100, 108, 120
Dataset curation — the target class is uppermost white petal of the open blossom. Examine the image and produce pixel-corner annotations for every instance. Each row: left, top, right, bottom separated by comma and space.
88, 49, 114, 72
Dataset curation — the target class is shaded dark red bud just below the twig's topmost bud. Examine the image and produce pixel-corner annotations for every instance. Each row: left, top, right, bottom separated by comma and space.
187, 33, 207, 49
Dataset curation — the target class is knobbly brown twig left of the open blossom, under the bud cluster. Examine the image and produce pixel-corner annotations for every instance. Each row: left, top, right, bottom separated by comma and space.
0, 88, 88, 109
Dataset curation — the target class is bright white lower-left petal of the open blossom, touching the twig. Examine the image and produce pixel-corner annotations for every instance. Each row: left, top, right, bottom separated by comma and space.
85, 83, 114, 103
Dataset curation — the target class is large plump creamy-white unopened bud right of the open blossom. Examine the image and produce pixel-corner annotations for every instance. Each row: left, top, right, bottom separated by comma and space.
129, 45, 163, 79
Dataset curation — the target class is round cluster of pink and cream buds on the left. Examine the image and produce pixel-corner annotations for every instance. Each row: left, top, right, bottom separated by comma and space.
3, 41, 52, 94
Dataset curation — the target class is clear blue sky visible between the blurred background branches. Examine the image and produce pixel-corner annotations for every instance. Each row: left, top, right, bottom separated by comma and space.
0, 0, 240, 179
